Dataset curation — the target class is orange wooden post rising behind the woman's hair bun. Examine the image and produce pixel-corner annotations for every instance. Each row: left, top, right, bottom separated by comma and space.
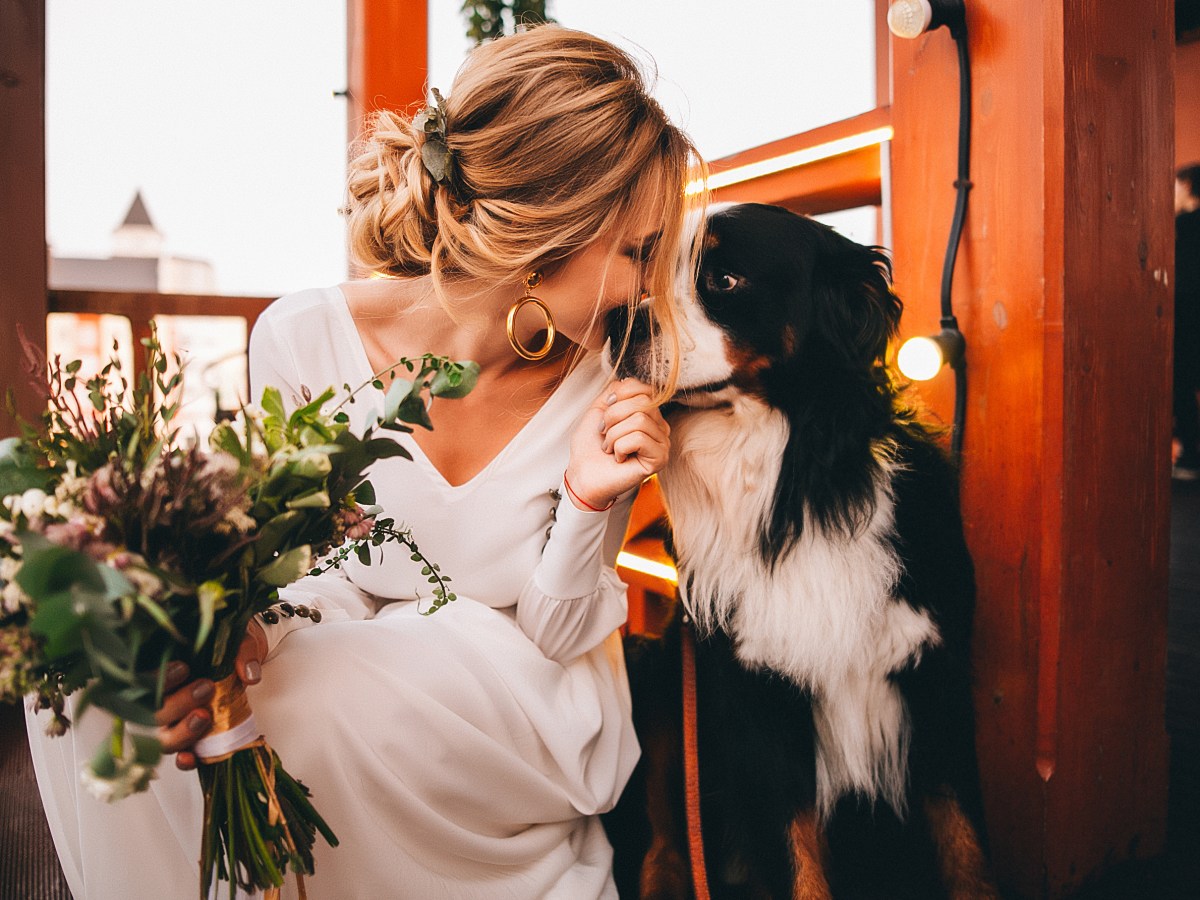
346, 0, 432, 142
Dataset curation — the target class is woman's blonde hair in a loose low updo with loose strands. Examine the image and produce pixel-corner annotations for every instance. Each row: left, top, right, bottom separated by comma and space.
349, 25, 703, 394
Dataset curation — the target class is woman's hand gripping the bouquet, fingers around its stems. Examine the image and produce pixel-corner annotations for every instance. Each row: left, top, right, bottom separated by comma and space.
165, 619, 266, 770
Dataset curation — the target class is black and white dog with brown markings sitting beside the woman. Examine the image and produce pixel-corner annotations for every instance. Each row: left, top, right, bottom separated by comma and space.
608, 204, 997, 900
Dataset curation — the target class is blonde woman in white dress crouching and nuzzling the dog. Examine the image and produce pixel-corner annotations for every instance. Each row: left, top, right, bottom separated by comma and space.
31, 26, 695, 900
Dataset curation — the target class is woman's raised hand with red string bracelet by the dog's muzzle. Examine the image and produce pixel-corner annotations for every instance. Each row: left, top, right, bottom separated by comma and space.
566, 378, 671, 509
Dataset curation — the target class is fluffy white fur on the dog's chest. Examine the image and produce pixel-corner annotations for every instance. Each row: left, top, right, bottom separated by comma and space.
660, 396, 940, 815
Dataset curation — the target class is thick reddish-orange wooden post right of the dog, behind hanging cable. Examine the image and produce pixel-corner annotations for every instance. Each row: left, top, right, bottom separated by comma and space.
892, 0, 1174, 898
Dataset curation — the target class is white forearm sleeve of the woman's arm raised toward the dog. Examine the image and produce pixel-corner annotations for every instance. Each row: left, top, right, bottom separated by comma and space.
517, 486, 636, 662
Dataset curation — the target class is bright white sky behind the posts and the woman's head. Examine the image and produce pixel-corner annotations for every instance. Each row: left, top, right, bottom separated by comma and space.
47, 0, 875, 295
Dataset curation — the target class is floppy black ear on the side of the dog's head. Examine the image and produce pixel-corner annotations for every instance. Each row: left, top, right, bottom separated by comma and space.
811, 226, 904, 366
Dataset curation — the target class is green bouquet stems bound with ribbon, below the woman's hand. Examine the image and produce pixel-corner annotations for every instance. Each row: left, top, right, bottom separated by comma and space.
198, 676, 337, 900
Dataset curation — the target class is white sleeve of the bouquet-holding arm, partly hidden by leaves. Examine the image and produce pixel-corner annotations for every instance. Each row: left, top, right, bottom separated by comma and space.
250, 307, 378, 658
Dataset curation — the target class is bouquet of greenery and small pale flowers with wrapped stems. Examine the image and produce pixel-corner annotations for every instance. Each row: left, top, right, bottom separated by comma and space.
0, 328, 479, 898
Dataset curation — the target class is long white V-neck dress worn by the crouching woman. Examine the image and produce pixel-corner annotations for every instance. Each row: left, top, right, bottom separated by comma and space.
29, 287, 638, 900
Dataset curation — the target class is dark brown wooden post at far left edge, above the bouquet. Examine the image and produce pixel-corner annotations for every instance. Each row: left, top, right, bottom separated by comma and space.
0, 0, 47, 437
